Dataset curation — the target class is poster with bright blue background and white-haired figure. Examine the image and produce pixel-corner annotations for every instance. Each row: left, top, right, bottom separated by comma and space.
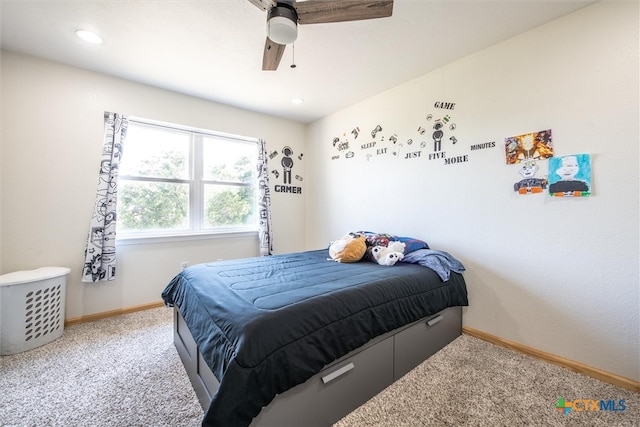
549, 154, 591, 197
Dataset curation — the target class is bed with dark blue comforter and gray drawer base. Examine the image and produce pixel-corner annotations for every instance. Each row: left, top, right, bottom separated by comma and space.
162, 246, 468, 426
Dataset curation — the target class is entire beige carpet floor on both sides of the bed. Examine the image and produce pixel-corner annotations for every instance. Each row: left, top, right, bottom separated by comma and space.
0, 308, 640, 427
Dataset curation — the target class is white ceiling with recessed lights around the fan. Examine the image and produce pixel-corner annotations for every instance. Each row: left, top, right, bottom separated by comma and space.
0, 0, 595, 123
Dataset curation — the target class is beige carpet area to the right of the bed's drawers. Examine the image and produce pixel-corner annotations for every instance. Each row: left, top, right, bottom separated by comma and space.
335, 335, 640, 427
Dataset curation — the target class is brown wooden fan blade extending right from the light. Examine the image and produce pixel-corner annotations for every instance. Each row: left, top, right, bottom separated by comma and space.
296, 0, 393, 24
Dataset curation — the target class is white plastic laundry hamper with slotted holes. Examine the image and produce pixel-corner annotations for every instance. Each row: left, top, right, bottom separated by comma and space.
0, 267, 70, 356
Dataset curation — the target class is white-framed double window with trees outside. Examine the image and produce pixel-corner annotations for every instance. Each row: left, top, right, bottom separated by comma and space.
117, 119, 258, 238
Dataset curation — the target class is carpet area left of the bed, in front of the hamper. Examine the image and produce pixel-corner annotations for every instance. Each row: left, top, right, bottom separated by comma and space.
0, 308, 202, 427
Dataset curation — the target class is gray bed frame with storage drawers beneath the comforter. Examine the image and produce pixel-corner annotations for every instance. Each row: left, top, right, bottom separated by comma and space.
174, 307, 462, 427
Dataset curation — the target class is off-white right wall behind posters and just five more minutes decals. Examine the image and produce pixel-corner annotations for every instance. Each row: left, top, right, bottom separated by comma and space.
306, 2, 640, 380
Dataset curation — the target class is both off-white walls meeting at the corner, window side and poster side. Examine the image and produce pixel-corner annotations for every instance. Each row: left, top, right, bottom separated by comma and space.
0, 2, 640, 380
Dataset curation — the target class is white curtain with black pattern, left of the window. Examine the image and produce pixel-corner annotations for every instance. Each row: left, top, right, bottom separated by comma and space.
82, 112, 129, 282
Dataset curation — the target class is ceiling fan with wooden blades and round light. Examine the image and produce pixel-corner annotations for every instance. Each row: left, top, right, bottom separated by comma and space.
249, 0, 393, 70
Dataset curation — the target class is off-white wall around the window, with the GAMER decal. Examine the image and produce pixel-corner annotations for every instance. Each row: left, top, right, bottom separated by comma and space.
0, 51, 305, 318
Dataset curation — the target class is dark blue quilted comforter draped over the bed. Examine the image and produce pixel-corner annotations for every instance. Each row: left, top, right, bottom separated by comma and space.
162, 250, 468, 427
